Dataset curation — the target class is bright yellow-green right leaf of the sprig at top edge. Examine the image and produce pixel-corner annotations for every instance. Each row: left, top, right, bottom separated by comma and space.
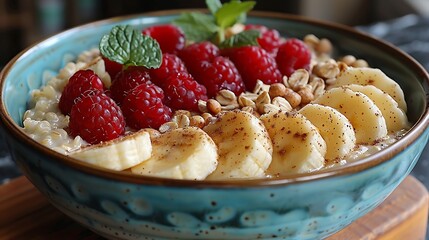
214, 1, 256, 29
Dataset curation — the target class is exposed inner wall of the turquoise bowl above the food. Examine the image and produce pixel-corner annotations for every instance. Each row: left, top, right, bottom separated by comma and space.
0, 12, 429, 182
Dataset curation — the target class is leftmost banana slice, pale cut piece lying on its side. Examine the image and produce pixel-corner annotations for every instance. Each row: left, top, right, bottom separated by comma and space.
70, 131, 152, 171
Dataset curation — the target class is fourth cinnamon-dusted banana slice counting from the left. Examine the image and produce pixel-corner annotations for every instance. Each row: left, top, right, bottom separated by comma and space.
261, 112, 326, 176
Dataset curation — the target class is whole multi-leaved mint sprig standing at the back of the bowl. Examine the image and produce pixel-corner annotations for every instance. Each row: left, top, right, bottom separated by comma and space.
173, 0, 256, 45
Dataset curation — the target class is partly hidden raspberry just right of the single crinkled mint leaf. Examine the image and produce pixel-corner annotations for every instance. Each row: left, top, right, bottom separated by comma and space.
148, 53, 187, 87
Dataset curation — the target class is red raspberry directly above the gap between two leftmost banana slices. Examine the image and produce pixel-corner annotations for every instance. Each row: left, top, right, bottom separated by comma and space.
121, 83, 172, 130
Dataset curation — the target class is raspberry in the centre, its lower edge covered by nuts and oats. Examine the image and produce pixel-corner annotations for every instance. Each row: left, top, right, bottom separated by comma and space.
195, 56, 245, 97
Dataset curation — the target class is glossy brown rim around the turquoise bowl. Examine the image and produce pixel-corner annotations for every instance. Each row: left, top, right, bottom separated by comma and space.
0, 8, 429, 188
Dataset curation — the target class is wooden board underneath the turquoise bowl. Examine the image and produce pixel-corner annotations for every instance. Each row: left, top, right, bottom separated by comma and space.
0, 176, 429, 240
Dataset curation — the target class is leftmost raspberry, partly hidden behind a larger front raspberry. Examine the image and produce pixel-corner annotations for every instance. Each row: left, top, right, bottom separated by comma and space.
58, 70, 104, 115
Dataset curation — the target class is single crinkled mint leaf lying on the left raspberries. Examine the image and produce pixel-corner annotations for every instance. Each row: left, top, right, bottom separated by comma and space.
99, 25, 162, 68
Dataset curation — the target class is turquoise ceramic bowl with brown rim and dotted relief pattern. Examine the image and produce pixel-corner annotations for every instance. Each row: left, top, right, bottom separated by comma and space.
0, 11, 429, 239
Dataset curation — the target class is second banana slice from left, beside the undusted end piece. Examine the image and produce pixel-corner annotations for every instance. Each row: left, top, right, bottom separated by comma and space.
131, 127, 218, 180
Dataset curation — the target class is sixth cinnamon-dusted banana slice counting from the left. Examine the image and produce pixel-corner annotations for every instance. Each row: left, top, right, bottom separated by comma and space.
313, 87, 387, 144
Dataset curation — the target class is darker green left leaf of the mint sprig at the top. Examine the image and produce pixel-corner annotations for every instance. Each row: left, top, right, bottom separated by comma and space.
173, 12, 219, 42
